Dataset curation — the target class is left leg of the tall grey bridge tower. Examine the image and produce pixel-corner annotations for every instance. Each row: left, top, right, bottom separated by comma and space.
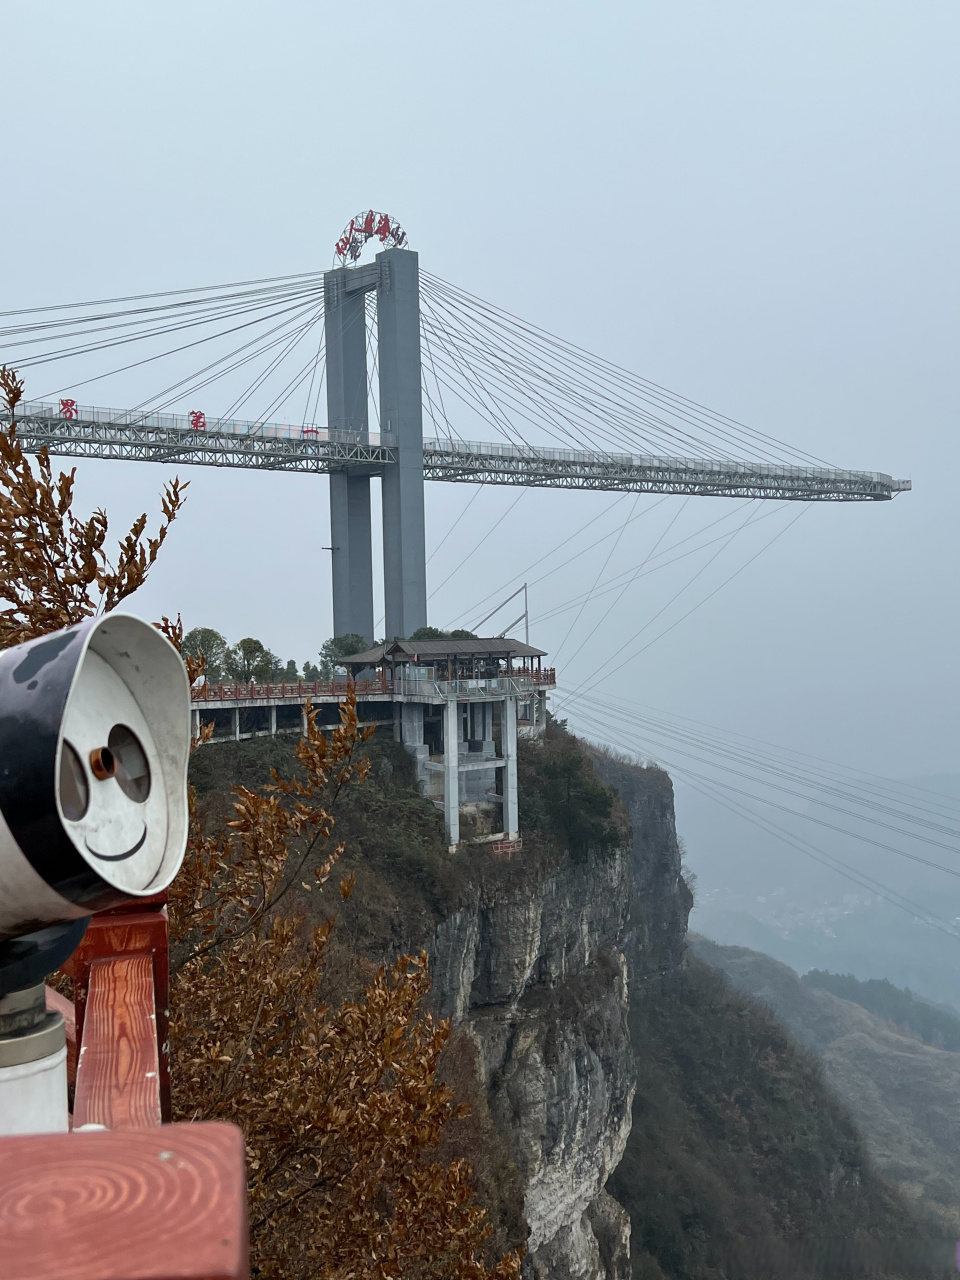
324, 268, 374, 644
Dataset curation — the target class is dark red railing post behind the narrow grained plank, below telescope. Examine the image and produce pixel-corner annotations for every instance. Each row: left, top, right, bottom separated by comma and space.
64, 893, 172, 1120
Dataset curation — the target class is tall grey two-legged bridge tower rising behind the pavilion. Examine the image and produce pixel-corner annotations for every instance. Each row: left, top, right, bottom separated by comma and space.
324, 248, 426, 644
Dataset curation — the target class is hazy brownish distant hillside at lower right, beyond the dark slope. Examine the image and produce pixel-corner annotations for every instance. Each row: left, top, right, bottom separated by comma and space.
689, 934, 960, 1233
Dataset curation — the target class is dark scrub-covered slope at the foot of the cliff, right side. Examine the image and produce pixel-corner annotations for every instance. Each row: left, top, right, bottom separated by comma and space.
609, 956, 940, 1280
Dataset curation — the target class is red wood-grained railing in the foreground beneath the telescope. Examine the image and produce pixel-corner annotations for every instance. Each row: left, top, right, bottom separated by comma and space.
0, 895, 250, 1280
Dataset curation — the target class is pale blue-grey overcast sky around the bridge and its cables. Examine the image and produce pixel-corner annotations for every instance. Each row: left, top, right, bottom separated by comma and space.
0, 0, 960, 776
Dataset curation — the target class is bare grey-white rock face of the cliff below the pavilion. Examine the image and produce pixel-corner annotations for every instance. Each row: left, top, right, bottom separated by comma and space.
430, 748, 690, 1280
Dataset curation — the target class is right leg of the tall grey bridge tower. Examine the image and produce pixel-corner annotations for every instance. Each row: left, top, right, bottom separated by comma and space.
378, 248, 426, 636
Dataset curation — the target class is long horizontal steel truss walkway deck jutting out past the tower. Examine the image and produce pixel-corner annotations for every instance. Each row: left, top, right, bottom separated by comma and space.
7, 413, 910, 502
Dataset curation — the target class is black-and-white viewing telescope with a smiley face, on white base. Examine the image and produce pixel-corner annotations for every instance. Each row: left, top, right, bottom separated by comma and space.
0, 613, 189, 1134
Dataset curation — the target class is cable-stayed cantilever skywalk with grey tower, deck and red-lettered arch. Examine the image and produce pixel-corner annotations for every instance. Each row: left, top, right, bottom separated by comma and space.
0, 211, 910, 641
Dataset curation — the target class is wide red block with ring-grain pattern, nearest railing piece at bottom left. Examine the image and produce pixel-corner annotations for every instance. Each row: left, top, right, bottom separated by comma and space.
0, 1124, 250, 1280
